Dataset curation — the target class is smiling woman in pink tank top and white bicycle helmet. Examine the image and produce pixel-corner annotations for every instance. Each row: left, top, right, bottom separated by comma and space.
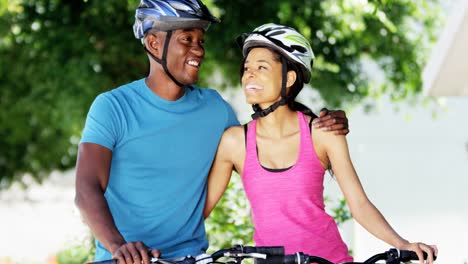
204, 24, 437, 263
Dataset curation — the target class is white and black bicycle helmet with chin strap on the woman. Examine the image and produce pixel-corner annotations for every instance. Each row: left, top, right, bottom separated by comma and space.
236, 23, 314, 119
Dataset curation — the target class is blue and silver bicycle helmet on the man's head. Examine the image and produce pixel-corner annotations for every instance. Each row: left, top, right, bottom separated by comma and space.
133, 0, 220, 39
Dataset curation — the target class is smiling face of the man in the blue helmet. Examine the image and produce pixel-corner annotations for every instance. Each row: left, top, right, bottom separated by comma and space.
167, 28, 205, 84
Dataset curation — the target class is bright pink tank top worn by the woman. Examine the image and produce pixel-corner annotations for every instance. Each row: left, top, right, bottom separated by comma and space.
242, 112, 353, 263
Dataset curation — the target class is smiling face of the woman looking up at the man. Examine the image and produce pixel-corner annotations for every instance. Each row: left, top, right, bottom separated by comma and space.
241, 48, 282, 105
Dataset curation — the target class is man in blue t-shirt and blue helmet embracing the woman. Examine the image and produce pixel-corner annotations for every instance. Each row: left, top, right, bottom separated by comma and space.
75, 0, 348, 264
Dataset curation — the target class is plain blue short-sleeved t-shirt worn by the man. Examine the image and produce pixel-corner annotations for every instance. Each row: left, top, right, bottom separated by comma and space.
80, 79, 239, 261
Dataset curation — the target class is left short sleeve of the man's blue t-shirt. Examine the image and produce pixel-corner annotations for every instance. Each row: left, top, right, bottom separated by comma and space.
80, 93, 121, 150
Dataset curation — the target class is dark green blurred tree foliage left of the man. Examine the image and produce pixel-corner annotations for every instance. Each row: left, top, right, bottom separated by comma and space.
0, 0, 147, 189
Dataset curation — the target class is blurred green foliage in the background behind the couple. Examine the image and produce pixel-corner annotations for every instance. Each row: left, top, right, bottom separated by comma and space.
0, 0, 443, 260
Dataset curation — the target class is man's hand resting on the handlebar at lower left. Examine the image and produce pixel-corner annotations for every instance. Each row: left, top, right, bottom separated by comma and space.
112, 241, 161, 264
